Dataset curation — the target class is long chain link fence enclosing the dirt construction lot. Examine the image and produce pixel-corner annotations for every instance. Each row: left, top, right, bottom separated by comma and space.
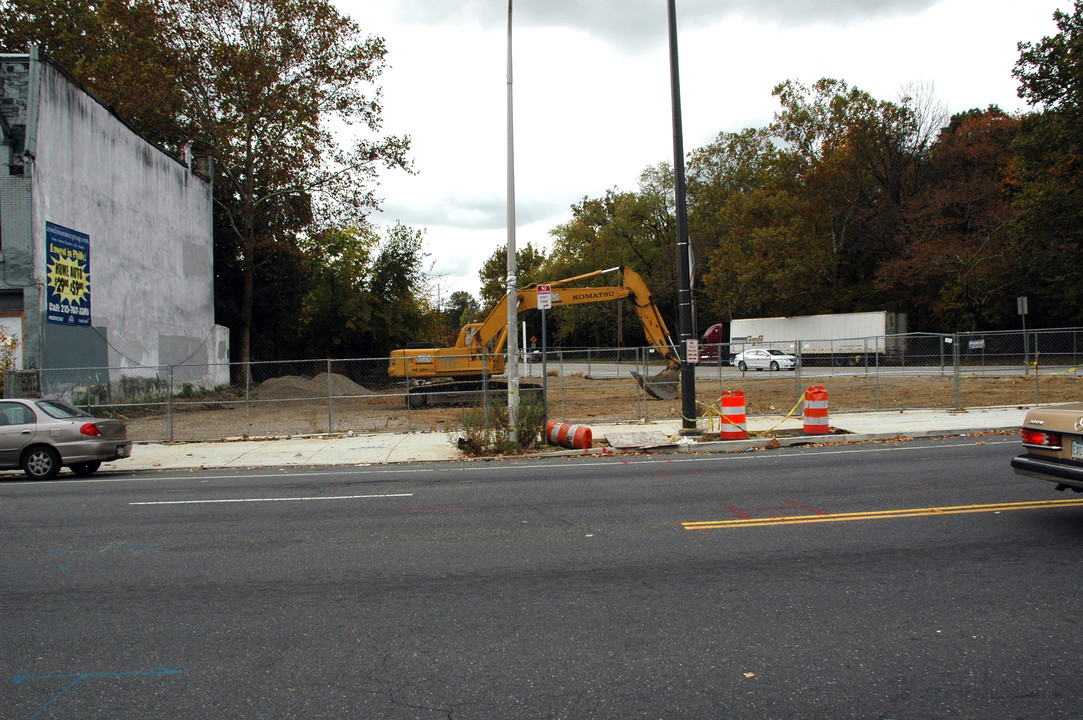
4, 328, 1083, 442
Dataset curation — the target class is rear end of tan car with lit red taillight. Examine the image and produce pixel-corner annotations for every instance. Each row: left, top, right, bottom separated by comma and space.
1012, 403, 1083, 493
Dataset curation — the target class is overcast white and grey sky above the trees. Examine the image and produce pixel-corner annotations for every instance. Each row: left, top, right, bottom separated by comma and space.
332, 0, 1072, 301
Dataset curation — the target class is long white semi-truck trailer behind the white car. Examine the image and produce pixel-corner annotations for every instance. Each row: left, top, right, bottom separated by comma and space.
729, 311, 906, 365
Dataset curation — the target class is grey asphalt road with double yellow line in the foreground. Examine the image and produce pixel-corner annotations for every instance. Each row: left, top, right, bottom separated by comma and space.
0, 435, 1083, 720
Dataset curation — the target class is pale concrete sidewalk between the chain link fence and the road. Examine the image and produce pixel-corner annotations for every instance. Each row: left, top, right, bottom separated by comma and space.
102, 407, 1027, 472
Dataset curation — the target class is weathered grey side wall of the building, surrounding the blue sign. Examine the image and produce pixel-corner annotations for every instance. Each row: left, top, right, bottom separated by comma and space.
30, 55, 227, 376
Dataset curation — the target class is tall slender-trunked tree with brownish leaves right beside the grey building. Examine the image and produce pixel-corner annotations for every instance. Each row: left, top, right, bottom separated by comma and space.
175, 0, 408, 362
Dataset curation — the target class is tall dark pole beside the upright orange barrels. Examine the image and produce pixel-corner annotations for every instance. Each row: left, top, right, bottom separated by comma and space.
669, 0, 699, 435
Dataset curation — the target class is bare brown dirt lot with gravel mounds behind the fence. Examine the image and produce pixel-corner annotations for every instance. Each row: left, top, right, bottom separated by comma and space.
122, 372, 1083, 442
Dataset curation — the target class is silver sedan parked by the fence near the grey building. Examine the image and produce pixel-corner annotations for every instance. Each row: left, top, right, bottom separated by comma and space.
0, 398, 132, 480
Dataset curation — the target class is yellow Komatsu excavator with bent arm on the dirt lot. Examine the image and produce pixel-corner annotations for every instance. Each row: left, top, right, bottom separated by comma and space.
388, 267, 681, 407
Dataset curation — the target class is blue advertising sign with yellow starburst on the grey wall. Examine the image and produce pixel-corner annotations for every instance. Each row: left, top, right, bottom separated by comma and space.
45, 222, 90, 327
